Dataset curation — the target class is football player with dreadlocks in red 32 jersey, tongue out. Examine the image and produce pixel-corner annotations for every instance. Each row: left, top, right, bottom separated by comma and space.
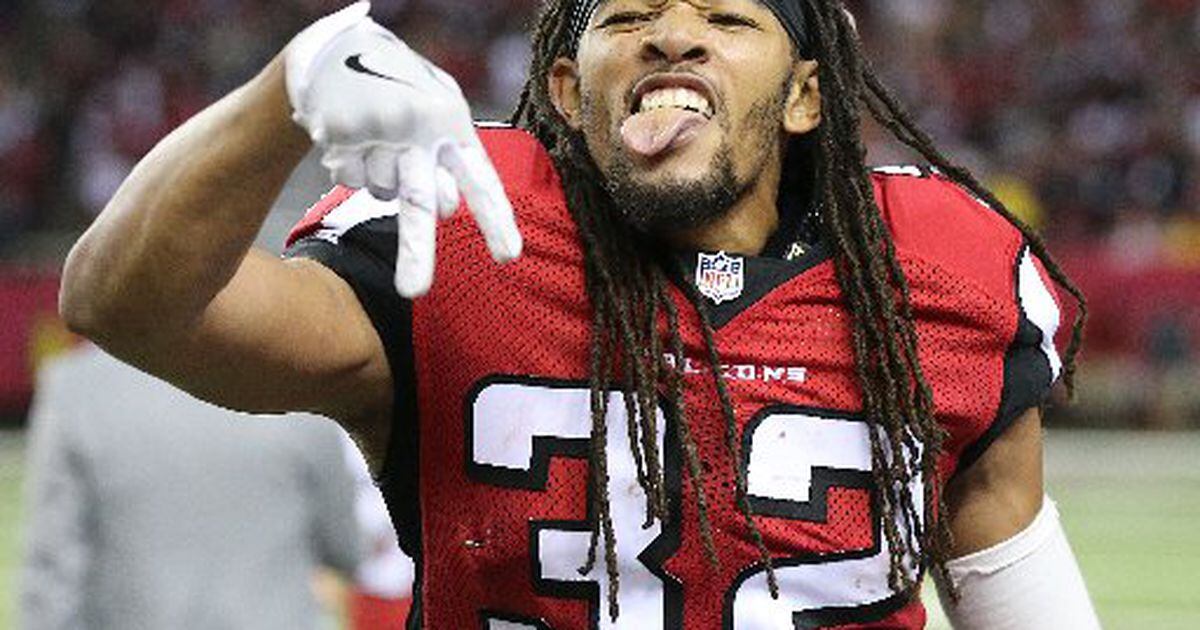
62, 0, 1097, 630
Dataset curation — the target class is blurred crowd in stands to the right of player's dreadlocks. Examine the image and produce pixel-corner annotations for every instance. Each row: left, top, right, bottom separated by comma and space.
863, 0, 1200, 266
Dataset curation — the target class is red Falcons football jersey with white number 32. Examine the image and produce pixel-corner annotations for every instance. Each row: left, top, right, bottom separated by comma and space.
289, 125, 1061, 630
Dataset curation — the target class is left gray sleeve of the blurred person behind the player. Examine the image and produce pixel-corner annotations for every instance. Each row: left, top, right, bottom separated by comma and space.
18, 357, 95, 630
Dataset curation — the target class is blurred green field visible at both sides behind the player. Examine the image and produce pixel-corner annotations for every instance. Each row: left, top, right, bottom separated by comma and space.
0, 432, 1200, 630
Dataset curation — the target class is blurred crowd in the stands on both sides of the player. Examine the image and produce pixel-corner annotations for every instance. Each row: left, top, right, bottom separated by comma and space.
0, 0, 1200, 254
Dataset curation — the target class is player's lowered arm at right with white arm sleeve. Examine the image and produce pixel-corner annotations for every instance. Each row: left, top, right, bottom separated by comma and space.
937, 408, 1099, 630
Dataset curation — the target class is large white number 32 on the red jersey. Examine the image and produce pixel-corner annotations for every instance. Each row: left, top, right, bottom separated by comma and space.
467, 379, 923, 630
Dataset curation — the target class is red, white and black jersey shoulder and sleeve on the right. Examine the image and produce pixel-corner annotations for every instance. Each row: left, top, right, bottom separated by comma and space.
875, 168, 1062, 470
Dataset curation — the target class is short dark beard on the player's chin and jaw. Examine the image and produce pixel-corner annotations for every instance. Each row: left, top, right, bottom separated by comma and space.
586, 78, 790, 235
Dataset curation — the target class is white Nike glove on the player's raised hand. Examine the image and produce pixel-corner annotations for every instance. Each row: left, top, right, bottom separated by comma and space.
284, 2, 522, 298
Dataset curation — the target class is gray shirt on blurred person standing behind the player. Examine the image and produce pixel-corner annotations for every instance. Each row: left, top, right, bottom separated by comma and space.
19, 348, 361, 630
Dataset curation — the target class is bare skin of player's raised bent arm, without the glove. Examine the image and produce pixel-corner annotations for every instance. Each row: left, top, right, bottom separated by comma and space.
60, 59, 391, 442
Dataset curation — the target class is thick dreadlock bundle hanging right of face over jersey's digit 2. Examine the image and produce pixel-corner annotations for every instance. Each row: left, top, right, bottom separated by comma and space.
812, 2, 940, 589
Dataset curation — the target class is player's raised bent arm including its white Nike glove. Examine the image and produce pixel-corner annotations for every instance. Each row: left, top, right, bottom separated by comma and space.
60, 4, 521, 455
